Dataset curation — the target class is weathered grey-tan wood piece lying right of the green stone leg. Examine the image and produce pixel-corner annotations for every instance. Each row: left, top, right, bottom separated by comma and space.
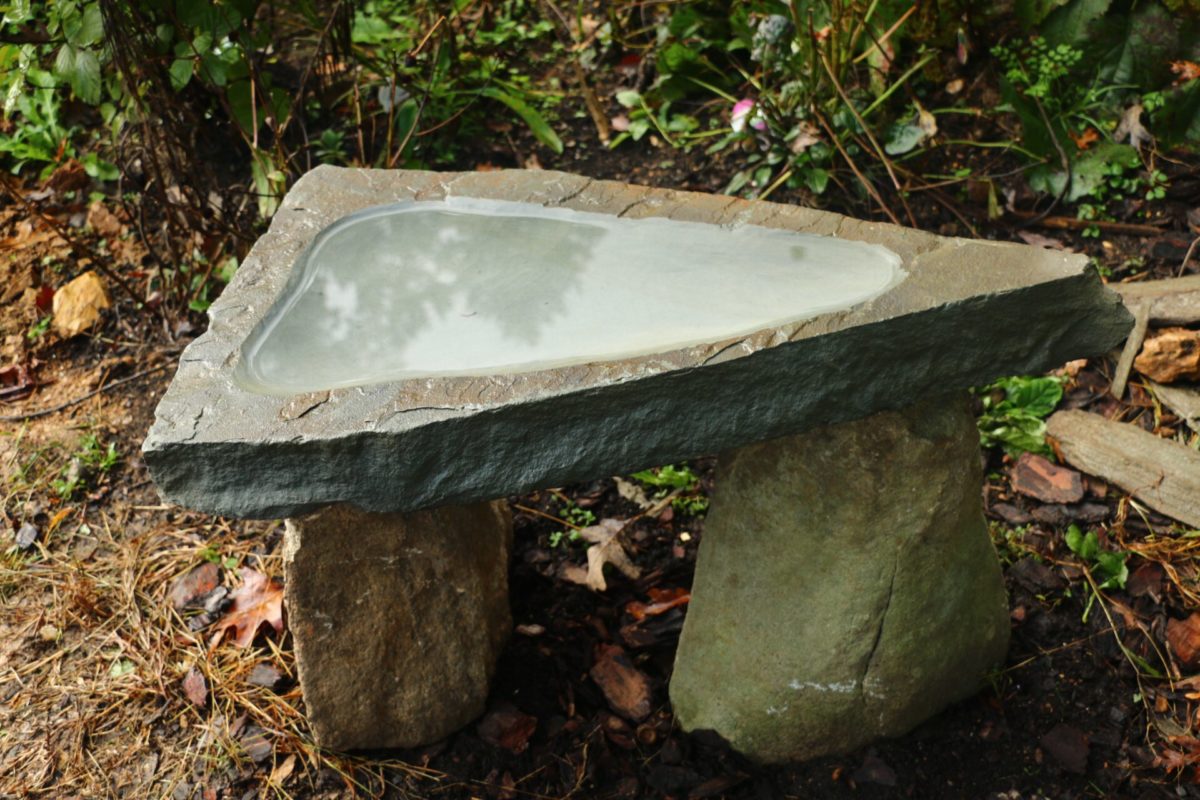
1046, 411, 1200, 528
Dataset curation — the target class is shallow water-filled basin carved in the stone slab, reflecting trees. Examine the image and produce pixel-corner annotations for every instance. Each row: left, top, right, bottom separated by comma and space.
235, 198, 904, 395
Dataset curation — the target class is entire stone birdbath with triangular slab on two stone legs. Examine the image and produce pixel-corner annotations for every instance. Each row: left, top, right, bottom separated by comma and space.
143, 167, 1130, 762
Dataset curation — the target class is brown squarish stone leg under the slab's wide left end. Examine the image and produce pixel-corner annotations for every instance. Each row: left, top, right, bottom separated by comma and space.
284, 503, 512, 750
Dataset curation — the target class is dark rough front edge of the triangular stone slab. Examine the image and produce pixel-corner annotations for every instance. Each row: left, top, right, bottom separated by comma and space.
145, 263, 1130, 518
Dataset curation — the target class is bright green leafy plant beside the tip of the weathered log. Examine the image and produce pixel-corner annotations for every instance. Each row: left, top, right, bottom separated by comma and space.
976, 377, 1063, 456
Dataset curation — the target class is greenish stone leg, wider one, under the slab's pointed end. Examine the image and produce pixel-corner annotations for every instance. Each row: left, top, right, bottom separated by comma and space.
671, 395, 1009, 763
